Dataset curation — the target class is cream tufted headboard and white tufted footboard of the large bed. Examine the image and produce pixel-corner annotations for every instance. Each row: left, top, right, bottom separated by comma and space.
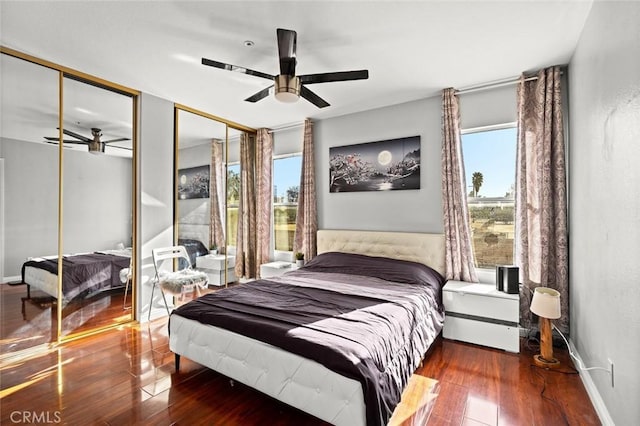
169, 230, 444, 426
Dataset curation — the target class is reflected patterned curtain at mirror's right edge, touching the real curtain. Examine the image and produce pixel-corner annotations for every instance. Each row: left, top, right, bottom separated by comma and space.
235, 133, 257, 278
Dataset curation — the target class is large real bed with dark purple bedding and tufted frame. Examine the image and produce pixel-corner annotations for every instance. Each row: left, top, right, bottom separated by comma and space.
169, 230, 444, 425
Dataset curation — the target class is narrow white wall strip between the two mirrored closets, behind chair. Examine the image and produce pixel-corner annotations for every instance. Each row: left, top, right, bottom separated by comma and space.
137, 93, 174, 322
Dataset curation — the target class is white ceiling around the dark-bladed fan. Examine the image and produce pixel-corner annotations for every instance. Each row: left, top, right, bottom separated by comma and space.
0, 0, 591, 133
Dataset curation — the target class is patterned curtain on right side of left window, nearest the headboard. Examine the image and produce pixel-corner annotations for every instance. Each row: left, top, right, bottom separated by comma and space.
293, 118, 318, 261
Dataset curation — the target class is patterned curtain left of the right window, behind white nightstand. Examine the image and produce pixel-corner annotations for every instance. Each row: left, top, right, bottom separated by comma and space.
442, 88, 478, 282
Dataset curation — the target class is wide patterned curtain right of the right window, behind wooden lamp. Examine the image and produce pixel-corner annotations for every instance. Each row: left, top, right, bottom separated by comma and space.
516, 67, 569, 332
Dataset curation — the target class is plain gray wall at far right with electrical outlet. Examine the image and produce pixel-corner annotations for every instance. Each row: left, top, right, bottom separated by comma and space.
569, 2, 640, 425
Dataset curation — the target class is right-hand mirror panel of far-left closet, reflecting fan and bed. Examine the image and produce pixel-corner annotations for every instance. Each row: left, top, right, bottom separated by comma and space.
61, 78, 133, 336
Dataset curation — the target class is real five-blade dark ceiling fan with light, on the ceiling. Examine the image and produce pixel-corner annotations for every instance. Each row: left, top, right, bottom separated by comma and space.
202, 28, 369, 108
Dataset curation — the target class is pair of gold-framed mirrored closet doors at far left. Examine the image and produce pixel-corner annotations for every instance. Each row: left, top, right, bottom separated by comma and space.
0, 48, 138, 353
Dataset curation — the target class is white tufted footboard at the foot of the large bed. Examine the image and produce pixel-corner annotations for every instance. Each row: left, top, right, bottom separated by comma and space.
169, 315, 366, 426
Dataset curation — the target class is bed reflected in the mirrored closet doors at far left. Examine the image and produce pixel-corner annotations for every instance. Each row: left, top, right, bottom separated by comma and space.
22, 248, 131, 305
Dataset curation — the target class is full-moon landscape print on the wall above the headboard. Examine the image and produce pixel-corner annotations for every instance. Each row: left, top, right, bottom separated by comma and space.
329, 136, 420, 192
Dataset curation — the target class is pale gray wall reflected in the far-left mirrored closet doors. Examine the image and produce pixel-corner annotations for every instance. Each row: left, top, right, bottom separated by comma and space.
0, 139, 132, 277
